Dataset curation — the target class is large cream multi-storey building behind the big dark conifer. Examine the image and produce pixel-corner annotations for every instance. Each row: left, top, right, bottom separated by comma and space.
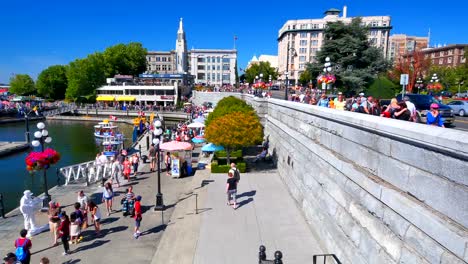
278, 6, 392, 83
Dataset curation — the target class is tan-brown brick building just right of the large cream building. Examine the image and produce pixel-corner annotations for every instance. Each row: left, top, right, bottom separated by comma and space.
387, 34, 429, 62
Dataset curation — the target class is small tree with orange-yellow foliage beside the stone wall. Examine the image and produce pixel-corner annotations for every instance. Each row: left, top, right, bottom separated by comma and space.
205, 112, 263, 164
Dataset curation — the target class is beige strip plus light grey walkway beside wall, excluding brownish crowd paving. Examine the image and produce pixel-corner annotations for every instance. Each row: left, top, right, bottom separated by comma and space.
151, 162, 323, 264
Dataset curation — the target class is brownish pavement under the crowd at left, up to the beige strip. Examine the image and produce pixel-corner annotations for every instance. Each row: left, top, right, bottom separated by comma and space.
0, 133, 192, 263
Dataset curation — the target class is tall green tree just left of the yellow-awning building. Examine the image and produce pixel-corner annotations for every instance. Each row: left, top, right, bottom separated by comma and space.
65, 53, 106, 101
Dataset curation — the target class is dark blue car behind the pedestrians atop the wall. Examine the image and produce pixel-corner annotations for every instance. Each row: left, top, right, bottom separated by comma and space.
397, 94, 455, 125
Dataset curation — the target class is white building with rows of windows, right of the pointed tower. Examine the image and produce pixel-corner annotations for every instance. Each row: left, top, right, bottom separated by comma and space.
188, 49, 237, 86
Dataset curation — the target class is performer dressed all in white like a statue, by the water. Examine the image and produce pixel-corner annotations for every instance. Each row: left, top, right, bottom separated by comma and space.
20, 190, 48, 236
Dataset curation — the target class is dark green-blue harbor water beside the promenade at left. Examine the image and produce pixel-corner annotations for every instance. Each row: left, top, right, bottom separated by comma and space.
0, 120, 133, 212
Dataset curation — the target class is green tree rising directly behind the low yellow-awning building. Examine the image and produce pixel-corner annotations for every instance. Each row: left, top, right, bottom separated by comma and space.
103, 42, 147, 77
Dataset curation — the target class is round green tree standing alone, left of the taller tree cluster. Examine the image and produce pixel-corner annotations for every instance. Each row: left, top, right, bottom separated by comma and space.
36, 65, 68, 100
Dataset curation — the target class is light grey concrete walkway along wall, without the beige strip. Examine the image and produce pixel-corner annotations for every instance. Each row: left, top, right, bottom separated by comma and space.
194, 170, 322, 264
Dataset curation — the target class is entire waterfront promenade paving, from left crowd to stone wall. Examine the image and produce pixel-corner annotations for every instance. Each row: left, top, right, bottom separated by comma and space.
0, 135, 322, 263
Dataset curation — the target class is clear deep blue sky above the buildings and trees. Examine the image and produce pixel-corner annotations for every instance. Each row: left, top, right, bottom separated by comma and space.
0, 0, 468, 83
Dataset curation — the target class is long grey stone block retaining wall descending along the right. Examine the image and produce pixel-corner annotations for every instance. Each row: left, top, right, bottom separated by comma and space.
243, 95, 468, 264
